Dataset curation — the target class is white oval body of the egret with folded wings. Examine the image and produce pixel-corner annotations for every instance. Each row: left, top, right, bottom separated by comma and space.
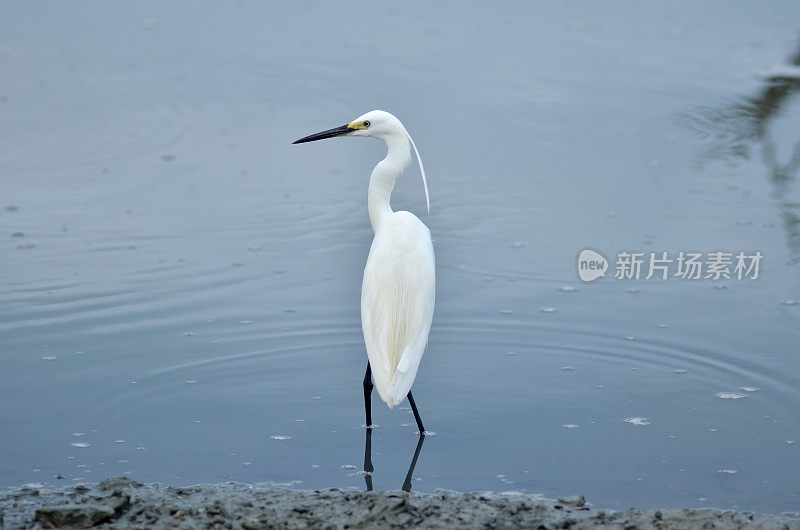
361, 212, 435, 407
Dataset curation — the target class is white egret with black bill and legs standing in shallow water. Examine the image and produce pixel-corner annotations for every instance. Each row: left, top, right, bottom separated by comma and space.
294, 110, 436, 435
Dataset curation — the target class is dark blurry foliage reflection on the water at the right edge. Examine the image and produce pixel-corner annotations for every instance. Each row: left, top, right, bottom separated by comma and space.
683, 39, 800, 254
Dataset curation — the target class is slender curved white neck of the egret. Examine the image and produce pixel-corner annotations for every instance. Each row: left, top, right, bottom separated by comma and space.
367, 134, 411, 232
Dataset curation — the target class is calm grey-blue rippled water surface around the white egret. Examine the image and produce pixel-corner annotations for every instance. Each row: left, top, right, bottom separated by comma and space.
0, 2, 800, 512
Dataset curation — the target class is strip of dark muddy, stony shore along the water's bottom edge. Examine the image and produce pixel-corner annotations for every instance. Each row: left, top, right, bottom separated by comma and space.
0, 477, 800, 530
